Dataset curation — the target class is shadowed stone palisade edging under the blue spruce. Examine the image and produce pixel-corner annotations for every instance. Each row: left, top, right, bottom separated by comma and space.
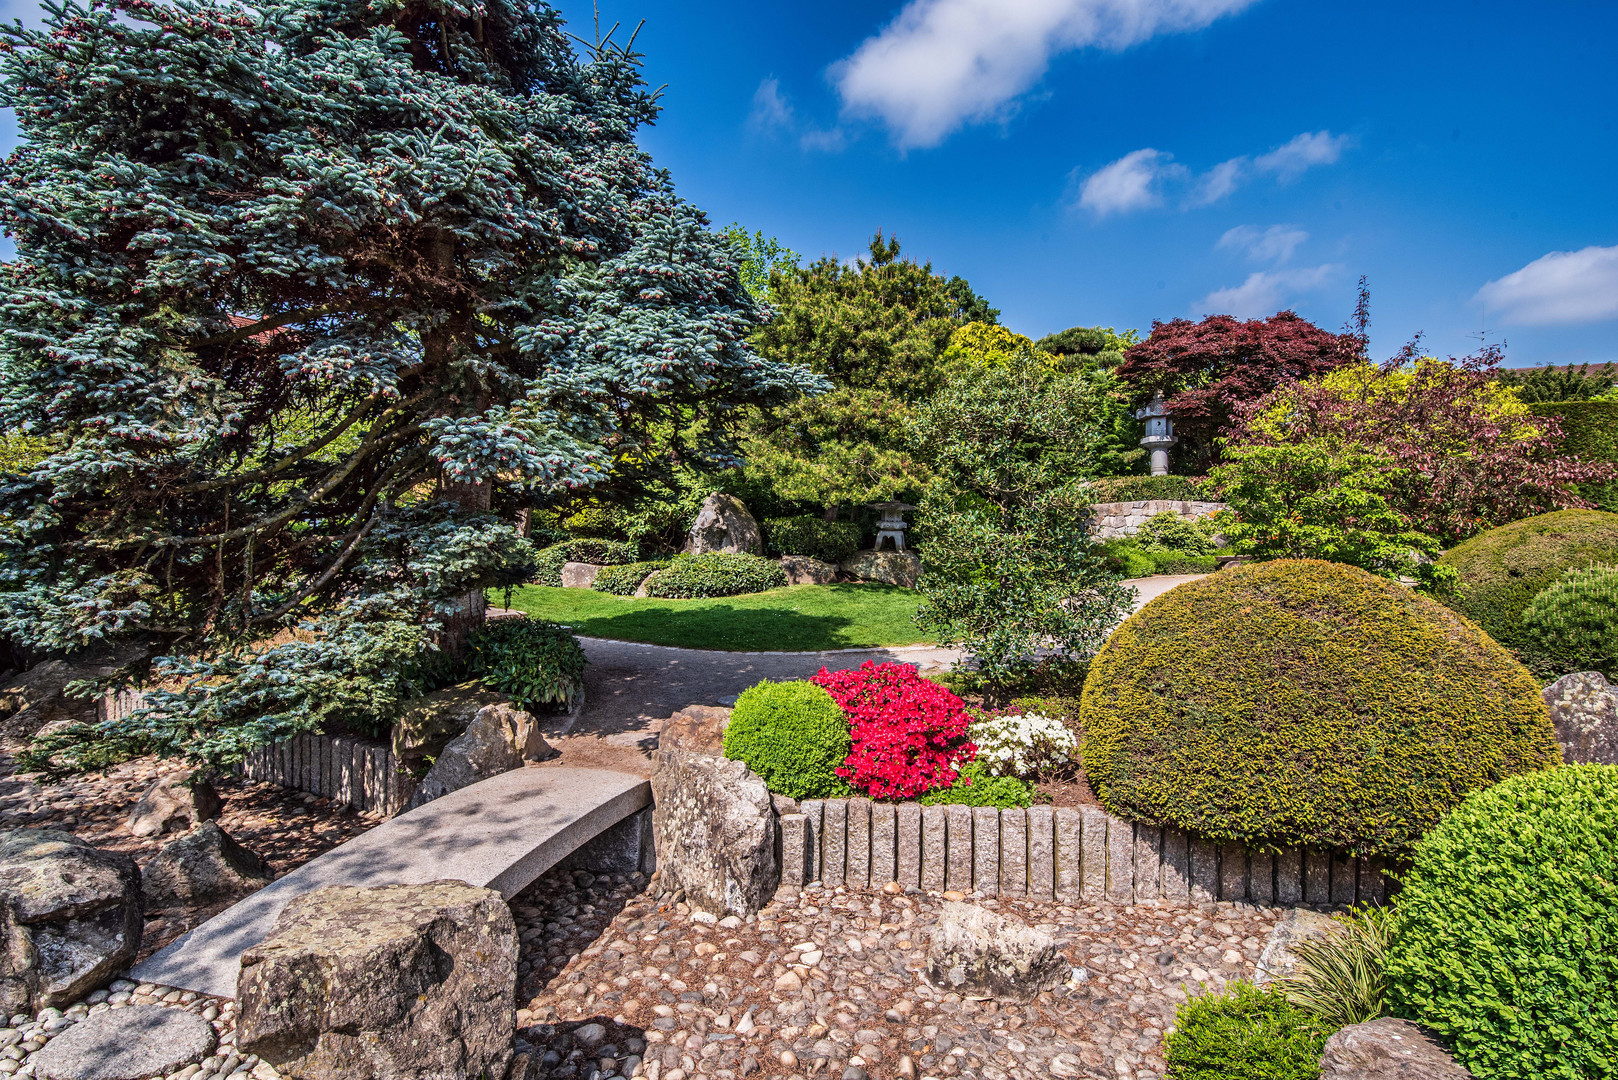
241, 735, 416, 818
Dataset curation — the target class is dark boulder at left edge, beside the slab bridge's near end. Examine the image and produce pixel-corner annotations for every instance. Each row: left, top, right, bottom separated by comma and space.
0, 829, 144, 1014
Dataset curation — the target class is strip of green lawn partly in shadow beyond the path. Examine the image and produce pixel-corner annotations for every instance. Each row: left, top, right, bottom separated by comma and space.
501, 585, 935, 651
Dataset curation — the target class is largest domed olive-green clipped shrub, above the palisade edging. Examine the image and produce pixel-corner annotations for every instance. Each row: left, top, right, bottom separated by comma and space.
1079, 559, 1560, 855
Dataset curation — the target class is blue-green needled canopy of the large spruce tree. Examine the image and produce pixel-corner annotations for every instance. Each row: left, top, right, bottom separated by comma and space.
0, 0, 817, 759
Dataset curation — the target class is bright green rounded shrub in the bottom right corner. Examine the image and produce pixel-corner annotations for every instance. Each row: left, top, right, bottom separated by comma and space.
1388, 764, 1618, 1080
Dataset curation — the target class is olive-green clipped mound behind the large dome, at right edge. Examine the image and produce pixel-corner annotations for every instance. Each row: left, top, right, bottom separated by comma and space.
1438, 510, 1618, 648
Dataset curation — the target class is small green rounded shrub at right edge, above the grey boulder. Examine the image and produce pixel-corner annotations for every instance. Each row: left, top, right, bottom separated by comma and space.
1523, 567, 1618, 680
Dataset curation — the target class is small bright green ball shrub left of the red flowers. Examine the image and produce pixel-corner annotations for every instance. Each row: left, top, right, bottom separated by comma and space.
725, 682, 851, 798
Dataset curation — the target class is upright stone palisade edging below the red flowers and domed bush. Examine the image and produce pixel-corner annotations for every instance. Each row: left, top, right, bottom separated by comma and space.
780, 798, 1388, 907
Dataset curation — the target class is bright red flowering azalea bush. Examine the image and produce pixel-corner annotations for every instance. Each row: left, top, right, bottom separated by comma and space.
811, 661, 977, 798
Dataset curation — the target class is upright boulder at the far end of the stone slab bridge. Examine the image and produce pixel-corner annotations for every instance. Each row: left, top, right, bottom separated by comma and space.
652, 748, 781, 915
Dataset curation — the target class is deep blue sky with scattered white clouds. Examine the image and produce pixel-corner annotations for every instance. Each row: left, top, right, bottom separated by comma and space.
0, 0, 1618, 364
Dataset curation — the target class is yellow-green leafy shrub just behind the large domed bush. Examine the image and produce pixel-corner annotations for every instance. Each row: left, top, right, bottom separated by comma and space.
1209, 440, 1453, 586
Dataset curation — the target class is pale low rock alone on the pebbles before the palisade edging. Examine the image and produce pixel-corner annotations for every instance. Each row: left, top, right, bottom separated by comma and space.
927, 900, 1073, 1001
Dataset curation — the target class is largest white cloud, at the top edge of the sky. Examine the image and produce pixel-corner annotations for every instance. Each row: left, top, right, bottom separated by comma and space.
830, 0, 1256, 147
